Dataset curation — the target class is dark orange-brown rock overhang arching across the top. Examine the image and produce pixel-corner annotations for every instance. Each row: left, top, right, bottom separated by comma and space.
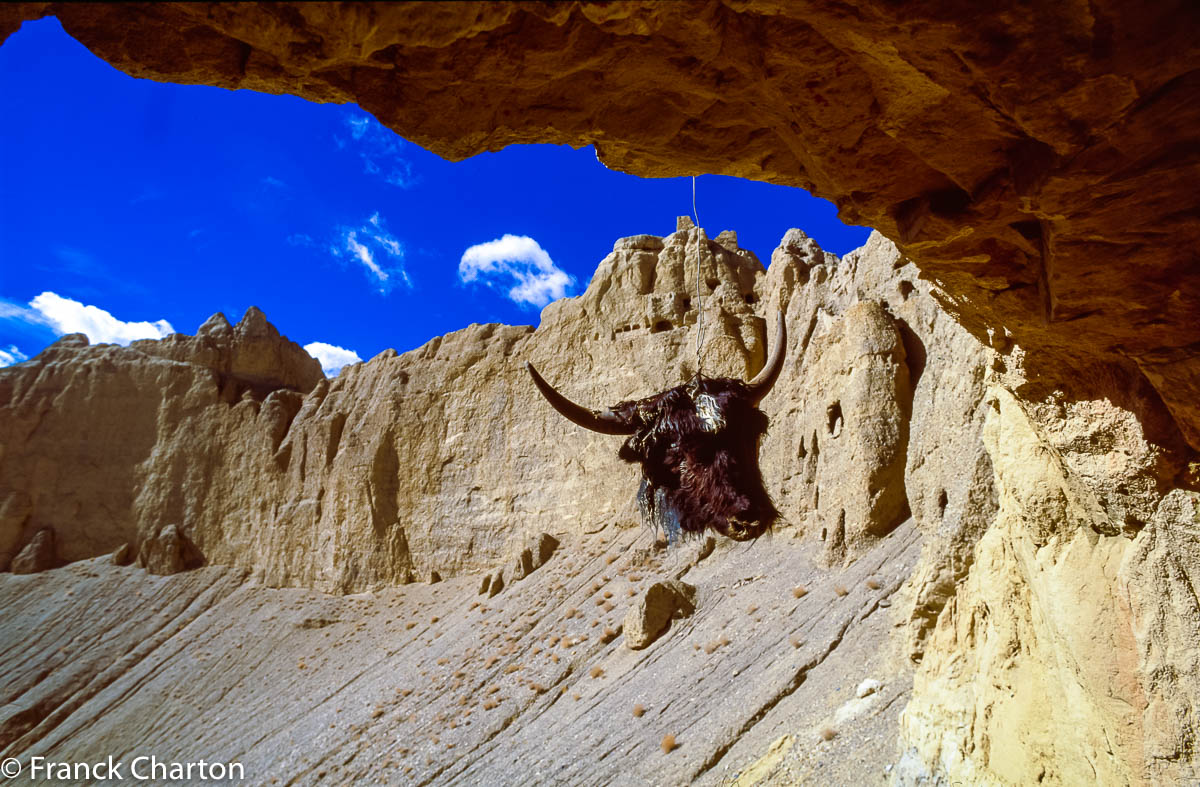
0, 0, 1200, 449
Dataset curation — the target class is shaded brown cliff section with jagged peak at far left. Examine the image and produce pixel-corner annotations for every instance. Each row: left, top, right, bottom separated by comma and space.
0, 308, 324, 566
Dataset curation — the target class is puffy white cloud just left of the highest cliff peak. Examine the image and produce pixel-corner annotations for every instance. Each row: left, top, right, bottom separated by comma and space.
458, 235, 575, 307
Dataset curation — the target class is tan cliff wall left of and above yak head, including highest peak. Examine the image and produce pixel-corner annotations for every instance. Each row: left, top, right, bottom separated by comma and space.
0, 222, 766, 593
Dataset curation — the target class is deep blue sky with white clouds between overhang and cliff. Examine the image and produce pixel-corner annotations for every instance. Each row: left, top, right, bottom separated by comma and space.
0, 18, 869, 370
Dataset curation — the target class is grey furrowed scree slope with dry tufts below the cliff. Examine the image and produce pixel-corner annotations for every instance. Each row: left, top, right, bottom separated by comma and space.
0, 523, 919, 785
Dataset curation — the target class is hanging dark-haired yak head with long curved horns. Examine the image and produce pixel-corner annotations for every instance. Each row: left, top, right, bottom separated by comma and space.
526, 313, 787, 541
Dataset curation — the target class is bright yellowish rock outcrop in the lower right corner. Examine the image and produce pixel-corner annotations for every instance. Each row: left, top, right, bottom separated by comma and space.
901, 388, 1200, 783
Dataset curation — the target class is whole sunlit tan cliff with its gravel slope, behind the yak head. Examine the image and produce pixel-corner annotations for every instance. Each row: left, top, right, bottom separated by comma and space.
0, 220, 1200, 783
